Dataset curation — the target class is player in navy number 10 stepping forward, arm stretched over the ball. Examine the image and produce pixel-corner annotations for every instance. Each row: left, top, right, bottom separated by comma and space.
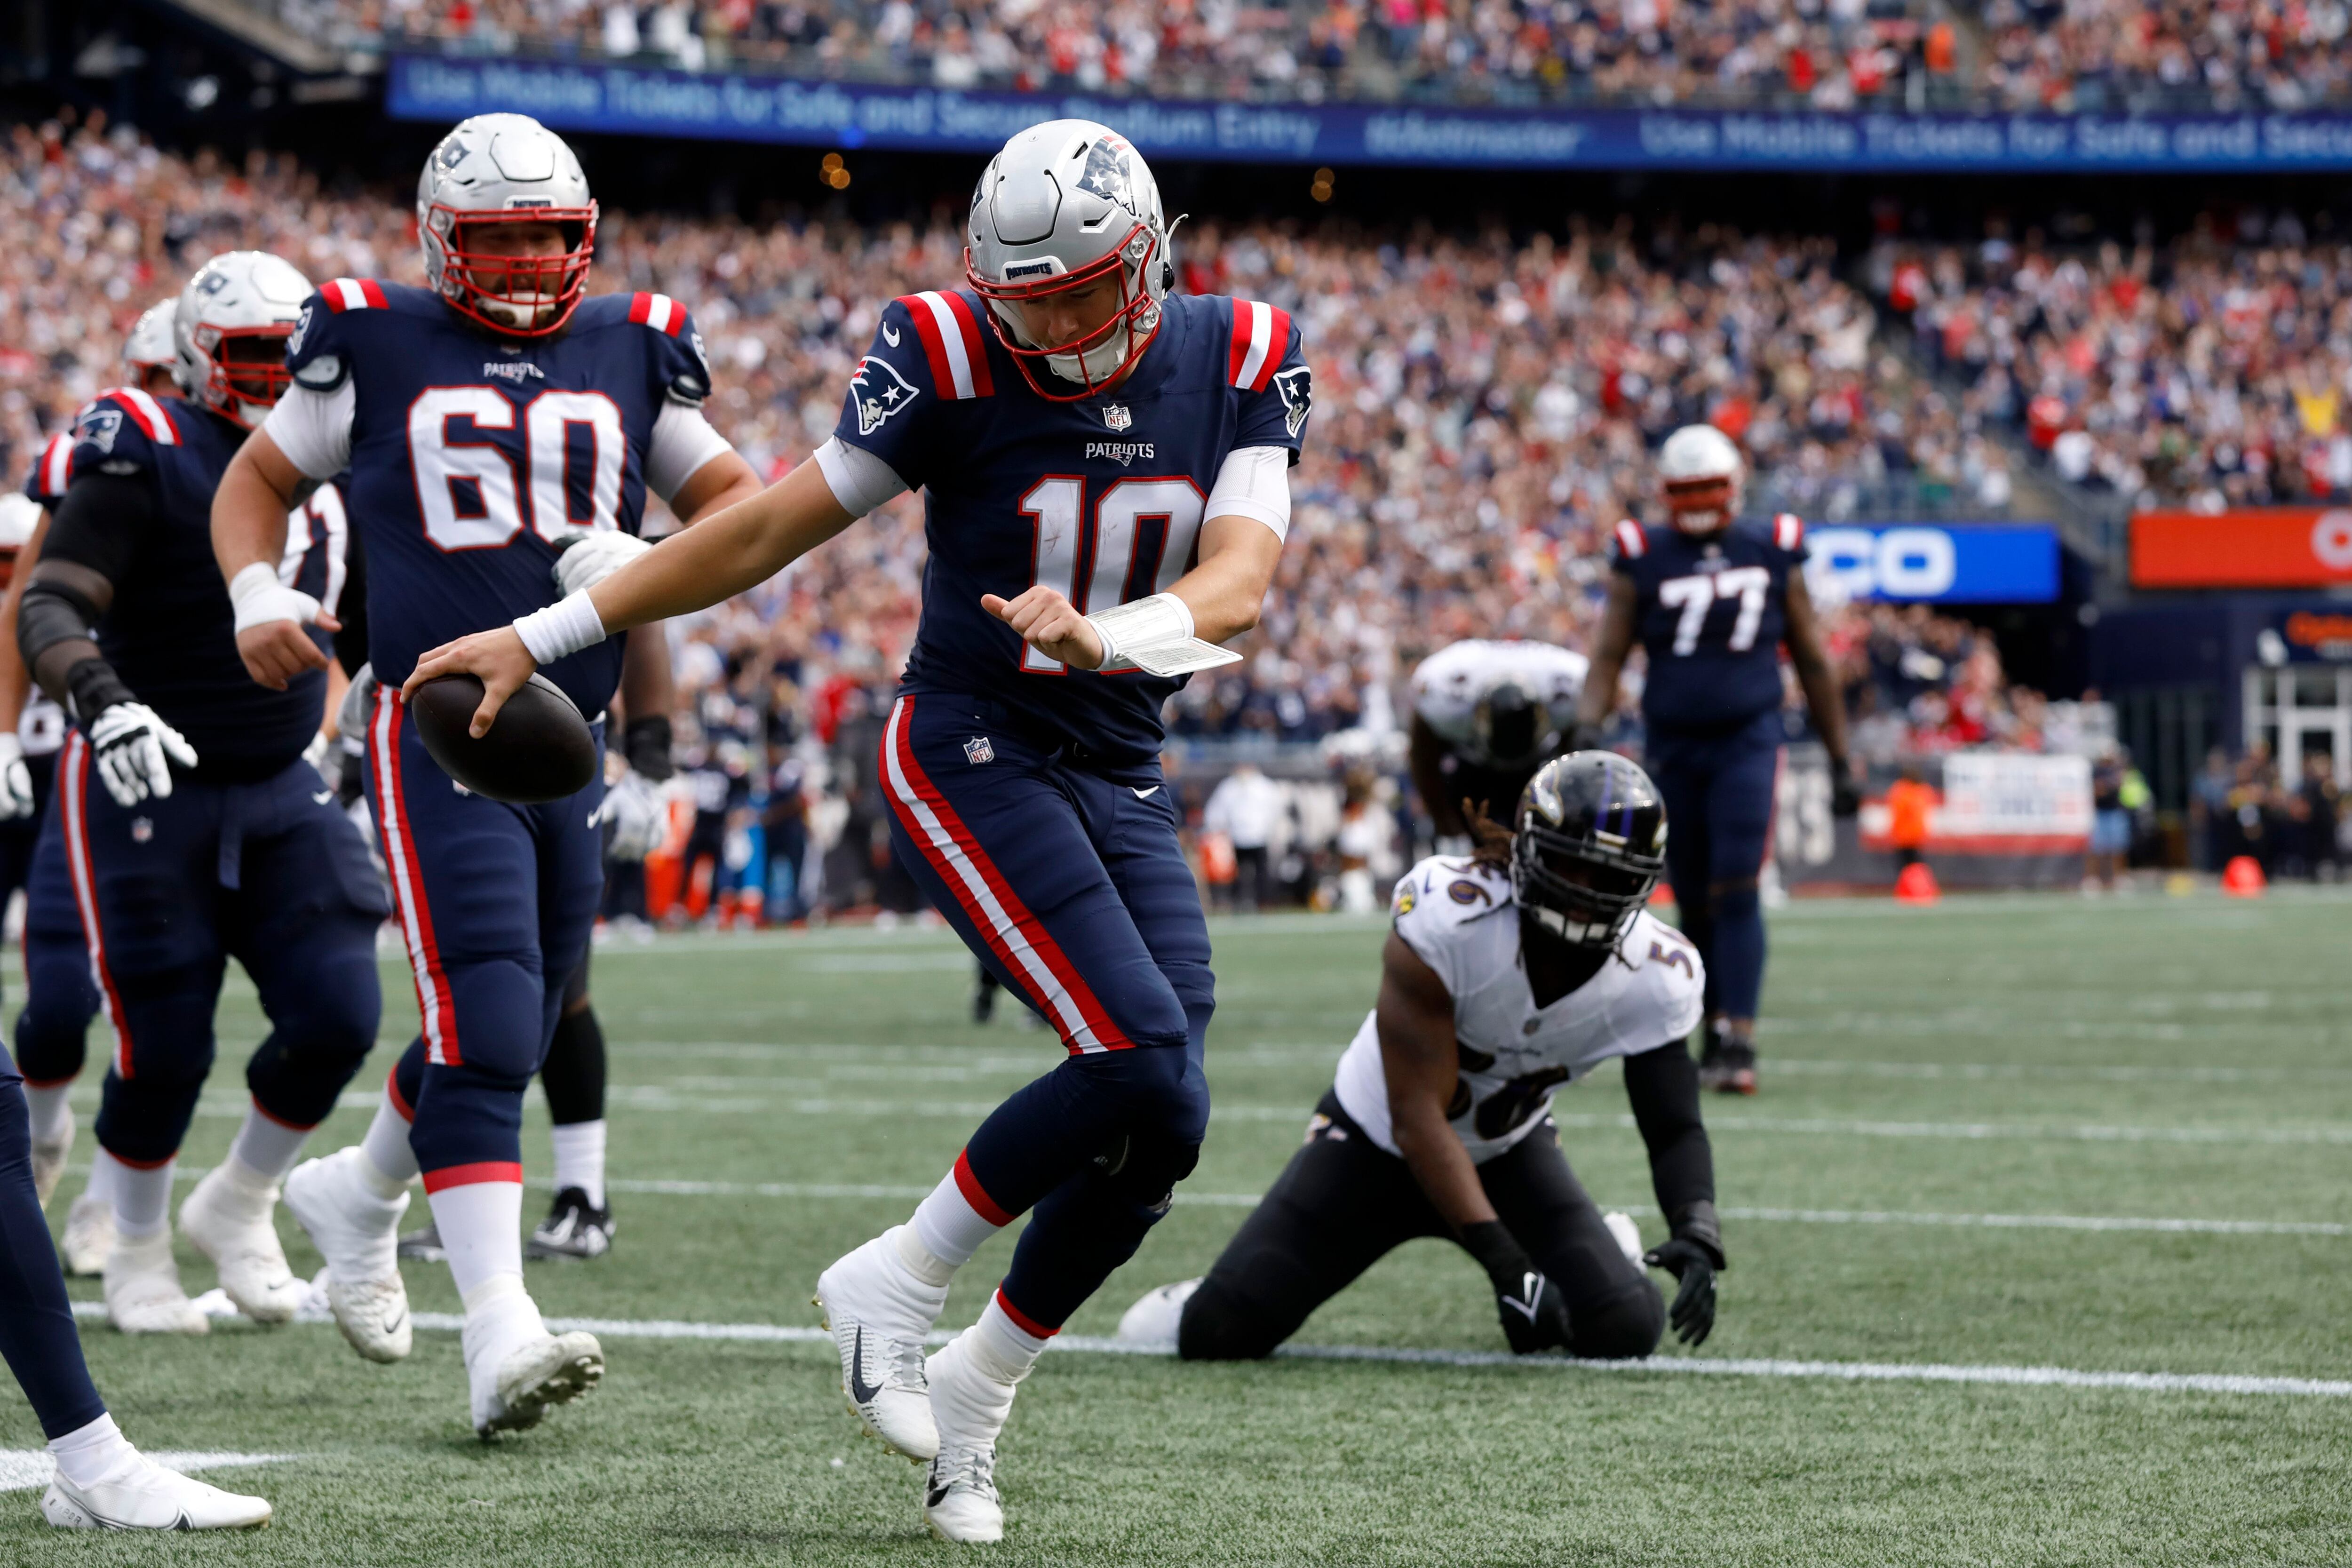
409, 120, 1310, 1540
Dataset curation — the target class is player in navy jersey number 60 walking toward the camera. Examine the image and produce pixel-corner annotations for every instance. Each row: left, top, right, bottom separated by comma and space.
214, 115, 760, 1436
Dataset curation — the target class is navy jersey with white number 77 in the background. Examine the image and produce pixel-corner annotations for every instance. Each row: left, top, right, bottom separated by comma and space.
1609, 512, 1804, 729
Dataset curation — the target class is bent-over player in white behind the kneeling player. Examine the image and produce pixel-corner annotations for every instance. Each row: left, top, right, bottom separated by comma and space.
1409, 637, 1585, 856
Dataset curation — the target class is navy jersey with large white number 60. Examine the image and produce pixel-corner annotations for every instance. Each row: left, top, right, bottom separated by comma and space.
270, 278, 710, 719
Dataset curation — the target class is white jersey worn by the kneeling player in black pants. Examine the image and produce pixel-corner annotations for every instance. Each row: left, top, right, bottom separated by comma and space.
1331, 856, 1708, 1164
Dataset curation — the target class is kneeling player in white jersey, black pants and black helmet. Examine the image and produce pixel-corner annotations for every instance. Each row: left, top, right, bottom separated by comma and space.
1120, 752, 1724, 1361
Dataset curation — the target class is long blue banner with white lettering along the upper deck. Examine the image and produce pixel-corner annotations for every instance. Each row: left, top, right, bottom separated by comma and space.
386, 54, 2352, 174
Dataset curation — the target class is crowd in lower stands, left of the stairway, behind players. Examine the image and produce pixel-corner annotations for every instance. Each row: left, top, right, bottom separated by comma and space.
0, 118, 2089, 907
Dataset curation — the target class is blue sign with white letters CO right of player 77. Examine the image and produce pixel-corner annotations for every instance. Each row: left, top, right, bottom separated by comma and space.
1804, 522, 2058, 604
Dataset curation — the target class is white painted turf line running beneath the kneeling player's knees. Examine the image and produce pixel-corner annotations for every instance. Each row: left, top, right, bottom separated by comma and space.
147, 1302, 2352, 1401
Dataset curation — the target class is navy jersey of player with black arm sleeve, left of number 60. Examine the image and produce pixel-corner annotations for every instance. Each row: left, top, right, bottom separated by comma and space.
71, 388, 343, 783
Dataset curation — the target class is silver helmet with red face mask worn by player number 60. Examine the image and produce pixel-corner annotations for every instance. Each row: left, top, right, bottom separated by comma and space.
416, 115, 595, 339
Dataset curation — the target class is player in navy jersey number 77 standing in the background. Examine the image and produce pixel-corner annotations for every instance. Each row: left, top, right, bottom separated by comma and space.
1576, 425, 1860, 1093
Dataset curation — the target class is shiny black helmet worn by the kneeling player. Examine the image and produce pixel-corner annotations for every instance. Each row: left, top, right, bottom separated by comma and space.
1510, 752, 1665, 947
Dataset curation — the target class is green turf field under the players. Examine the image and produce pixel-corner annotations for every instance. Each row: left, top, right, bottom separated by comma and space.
0, 893, 2352, 1568
